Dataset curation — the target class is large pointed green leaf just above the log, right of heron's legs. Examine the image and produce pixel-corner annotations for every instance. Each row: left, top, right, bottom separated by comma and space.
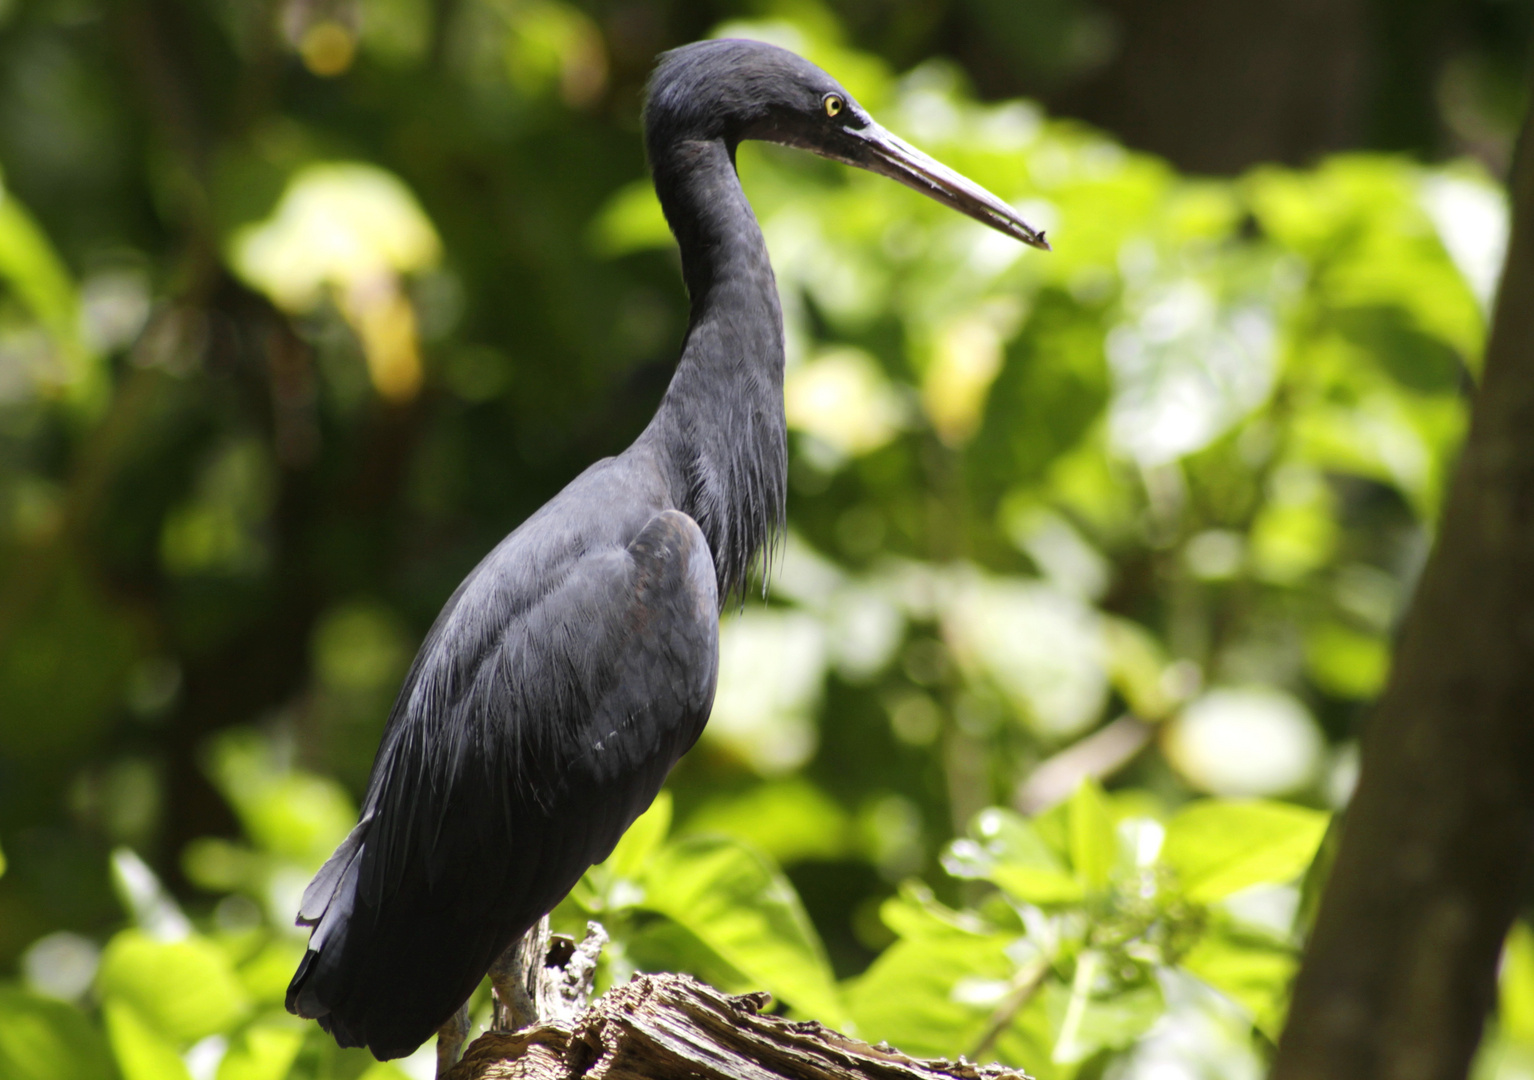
641, 836, 844, 1026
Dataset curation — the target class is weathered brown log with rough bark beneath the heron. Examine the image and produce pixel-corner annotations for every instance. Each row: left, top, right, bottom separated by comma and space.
446, 974, 1028, 1080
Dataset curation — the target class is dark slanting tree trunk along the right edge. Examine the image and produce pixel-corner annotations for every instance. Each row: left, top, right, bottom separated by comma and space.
1273, 95, 1534, 1080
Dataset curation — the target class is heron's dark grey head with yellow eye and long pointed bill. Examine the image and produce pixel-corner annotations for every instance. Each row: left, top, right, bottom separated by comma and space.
644, 38, 1049, 250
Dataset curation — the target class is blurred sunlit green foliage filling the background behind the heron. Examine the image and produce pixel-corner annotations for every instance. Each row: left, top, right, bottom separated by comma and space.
0, 0, 1534, 1080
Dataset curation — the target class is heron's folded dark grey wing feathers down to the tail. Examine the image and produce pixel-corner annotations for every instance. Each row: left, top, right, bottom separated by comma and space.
288, 511, 718, 1057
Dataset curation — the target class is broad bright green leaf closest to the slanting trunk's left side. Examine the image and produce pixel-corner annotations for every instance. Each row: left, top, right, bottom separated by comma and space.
1161, 799, 1328, 904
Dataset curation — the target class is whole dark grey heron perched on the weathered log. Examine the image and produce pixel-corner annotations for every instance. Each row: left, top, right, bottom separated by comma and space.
287, 40, 1048, 1066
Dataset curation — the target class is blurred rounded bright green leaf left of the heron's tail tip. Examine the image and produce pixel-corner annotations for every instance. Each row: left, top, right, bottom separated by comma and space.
97, 930, 250, 1045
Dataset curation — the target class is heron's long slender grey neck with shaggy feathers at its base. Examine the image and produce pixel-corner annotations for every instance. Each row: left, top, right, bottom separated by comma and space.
643, 140, 787, 604
